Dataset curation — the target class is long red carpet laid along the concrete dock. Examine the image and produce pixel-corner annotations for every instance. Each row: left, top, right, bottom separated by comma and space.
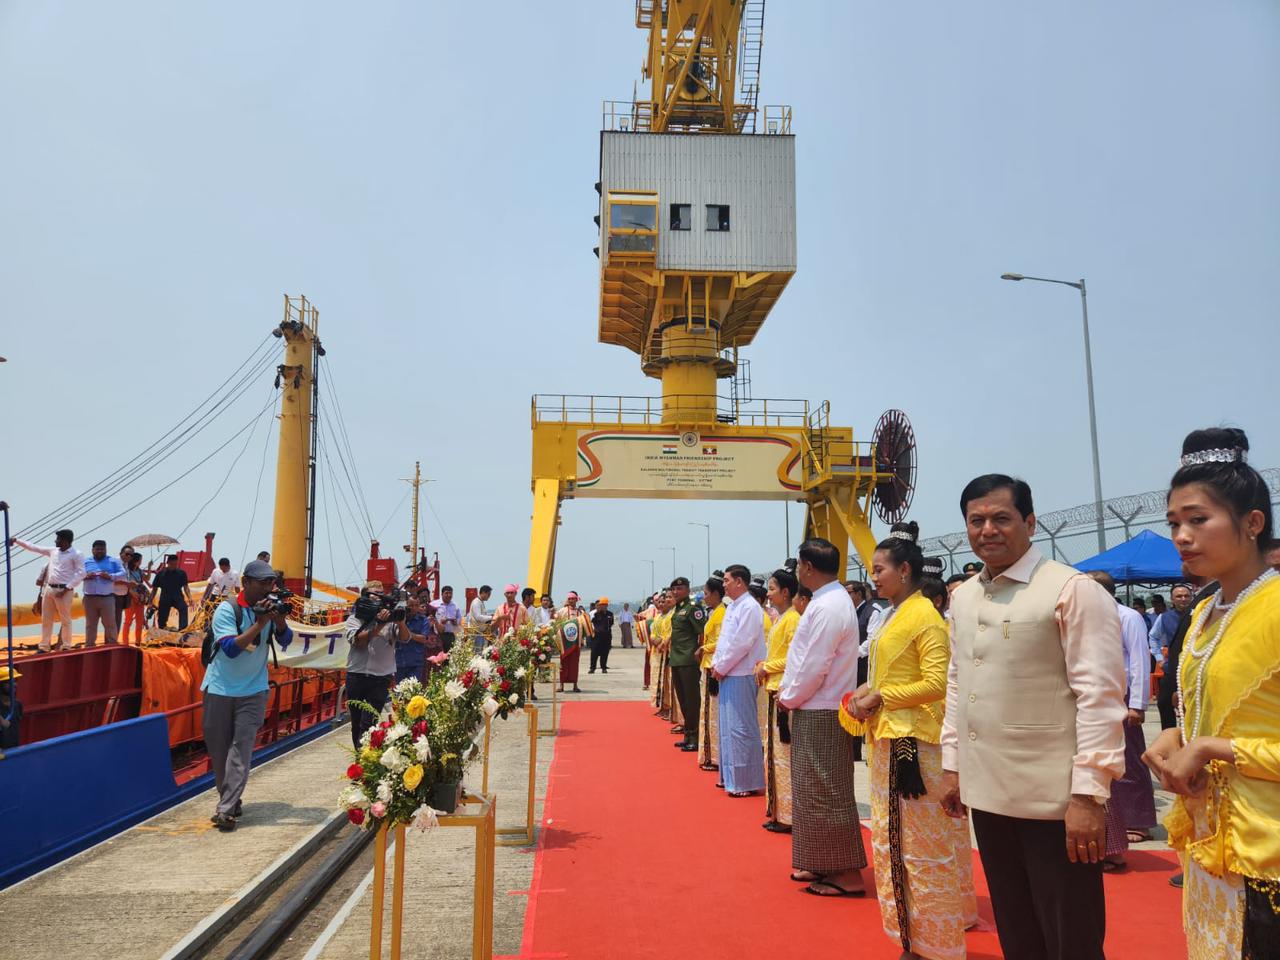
504, 703, 1185, 960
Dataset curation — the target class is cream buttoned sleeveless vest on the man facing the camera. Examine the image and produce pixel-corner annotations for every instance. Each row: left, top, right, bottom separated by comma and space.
951, 558, 1080, 820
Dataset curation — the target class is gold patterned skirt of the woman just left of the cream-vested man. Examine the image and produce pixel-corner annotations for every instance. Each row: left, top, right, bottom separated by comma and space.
870, 739, 978, 960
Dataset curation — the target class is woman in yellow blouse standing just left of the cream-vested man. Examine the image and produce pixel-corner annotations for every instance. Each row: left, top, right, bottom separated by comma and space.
846, 522, 978, 960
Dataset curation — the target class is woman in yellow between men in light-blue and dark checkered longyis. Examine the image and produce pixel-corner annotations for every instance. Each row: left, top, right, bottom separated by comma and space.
755, 570, 800, 833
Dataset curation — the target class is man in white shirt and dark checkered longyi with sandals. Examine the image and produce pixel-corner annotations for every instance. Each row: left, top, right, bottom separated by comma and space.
778, 538, 867, 897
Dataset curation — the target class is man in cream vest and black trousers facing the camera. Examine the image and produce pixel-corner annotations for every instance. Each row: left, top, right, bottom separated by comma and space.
941, 474, 1125, 960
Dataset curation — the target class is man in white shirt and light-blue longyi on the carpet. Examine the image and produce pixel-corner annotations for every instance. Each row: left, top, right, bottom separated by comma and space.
706, 563, 767, 797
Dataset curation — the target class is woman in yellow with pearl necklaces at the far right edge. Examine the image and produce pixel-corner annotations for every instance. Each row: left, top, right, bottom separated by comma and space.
1143, 429, 1280, 960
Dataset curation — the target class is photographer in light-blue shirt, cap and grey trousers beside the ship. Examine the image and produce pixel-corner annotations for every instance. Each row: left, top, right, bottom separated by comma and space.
201, 561, 293, 833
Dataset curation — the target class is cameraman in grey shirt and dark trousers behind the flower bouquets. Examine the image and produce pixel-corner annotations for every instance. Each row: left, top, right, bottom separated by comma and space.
346, 580, 408, 750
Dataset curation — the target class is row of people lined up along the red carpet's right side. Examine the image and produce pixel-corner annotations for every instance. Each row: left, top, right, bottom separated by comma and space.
634, 429, 1280, 960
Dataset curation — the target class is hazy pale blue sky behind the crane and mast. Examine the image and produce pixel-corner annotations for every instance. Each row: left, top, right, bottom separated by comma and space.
0, 0, 1280, 598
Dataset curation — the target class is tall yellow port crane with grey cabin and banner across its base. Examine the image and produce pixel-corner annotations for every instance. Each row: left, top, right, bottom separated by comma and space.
527, 0, 915, 593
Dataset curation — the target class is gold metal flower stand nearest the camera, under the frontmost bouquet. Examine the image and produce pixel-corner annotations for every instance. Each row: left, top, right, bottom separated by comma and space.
369, 794, 498, 960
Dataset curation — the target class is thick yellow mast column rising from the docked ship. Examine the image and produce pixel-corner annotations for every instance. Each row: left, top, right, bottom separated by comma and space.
271, 297, 319, 593
